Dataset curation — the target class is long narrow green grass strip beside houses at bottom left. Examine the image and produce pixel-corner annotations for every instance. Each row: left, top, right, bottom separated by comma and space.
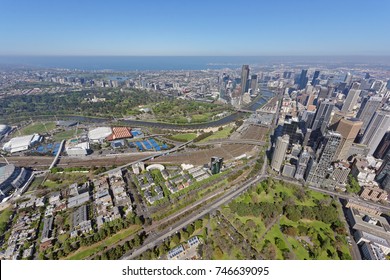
66, 225, 141, 260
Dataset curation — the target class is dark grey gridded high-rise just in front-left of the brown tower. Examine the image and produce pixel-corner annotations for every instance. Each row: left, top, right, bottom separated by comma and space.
307, 131, 342, 184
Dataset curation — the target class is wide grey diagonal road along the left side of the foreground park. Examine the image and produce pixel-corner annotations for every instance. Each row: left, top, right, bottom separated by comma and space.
121, 175, 268, 260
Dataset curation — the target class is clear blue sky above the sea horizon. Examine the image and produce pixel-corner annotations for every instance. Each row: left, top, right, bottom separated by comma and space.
0, 0, 390, 56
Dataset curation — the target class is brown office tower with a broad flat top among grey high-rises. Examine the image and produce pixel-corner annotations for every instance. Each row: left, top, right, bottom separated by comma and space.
335, 118, 363, 160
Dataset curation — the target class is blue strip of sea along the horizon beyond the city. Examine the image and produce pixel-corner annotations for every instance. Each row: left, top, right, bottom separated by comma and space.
0, 56, 390, 71
